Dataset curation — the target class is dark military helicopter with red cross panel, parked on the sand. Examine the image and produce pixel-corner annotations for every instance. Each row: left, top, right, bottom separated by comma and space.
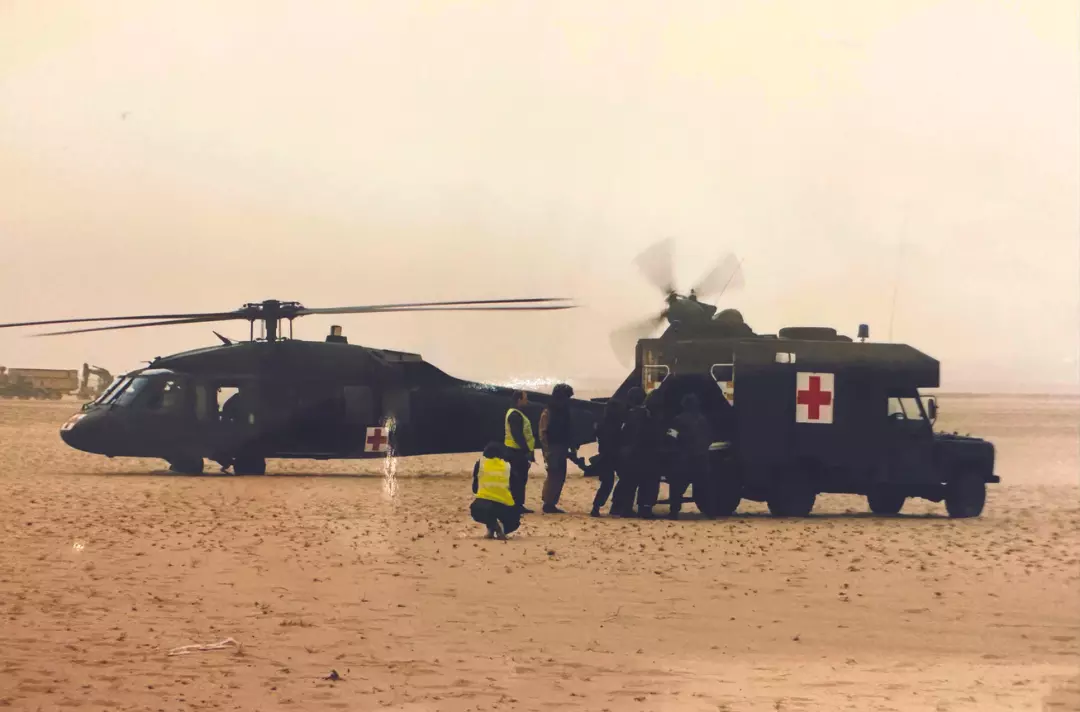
0, 297, 603, 474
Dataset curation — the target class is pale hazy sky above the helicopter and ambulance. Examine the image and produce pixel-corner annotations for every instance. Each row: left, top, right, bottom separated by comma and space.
0, 0, 1080, 388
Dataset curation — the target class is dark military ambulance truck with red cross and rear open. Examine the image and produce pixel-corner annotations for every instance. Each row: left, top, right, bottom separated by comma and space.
630, 325, 1000, 518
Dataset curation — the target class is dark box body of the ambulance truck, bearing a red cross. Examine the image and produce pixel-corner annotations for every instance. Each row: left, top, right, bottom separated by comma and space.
731, 339, 939, 496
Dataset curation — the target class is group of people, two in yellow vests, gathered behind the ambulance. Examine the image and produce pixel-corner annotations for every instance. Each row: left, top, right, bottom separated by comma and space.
471, 384, 712, 538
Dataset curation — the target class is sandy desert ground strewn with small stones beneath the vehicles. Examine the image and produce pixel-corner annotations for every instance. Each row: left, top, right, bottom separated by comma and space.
0, 395, 1080, 712
